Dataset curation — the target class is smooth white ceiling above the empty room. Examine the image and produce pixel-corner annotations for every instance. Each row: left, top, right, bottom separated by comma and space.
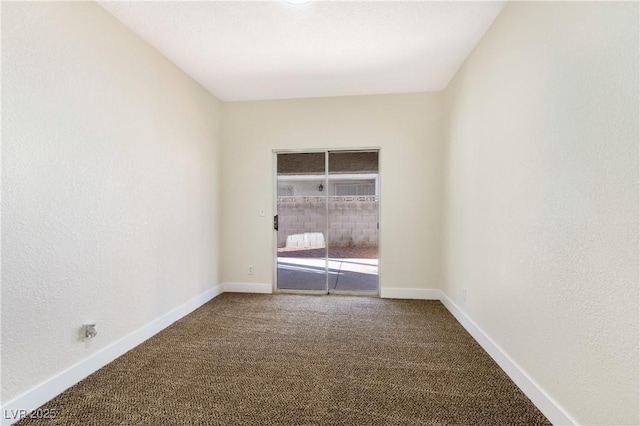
99, 0, 505, 101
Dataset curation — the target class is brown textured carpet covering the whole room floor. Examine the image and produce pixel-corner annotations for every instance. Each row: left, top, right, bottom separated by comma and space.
19, 293, 550, 426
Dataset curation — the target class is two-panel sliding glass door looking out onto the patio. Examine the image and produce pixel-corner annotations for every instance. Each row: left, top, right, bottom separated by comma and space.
274, 150, 379, 294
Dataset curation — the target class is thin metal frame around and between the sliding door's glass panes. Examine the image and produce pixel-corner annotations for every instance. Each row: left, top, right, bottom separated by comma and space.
271, 146, 382, 297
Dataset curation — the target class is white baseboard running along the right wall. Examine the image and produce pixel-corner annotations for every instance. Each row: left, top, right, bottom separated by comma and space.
440, 292, 577, 426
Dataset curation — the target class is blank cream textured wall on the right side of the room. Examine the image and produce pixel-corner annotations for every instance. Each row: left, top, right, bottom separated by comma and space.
443, 2, 640, 425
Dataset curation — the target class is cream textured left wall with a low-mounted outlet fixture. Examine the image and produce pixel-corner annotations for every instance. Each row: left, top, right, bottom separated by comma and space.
2, 2, 220, 403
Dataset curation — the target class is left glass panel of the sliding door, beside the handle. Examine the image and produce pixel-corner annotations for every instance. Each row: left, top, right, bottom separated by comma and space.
276, 152, 327, 292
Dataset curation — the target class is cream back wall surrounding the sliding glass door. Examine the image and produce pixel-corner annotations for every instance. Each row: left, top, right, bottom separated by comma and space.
222, 94, 441, 289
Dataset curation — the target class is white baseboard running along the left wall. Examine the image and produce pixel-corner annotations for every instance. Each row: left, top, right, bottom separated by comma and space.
0, 285, 223, 426
